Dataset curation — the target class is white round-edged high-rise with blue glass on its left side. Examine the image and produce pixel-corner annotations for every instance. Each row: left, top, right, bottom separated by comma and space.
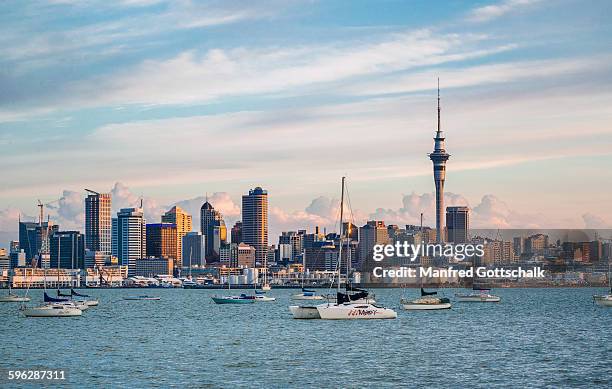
113, 208, 147, 275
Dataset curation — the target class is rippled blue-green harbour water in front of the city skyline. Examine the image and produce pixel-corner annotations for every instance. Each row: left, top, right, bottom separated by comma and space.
0, 288, 612, 388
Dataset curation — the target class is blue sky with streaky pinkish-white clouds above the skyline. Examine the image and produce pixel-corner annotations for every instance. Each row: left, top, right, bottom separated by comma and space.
0, 0, 612, 247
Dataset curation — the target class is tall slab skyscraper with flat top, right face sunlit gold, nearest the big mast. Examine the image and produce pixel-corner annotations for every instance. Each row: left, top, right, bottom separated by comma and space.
242, 186, 268, 264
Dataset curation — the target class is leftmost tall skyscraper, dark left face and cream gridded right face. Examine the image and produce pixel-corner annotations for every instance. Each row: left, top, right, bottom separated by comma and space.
85, 189, 112, 254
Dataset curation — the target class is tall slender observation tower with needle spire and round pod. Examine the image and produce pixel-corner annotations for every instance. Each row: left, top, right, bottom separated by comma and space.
429, 78, 450, 243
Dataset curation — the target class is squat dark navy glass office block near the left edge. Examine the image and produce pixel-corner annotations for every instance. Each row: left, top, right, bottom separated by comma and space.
49, 231, 85, 269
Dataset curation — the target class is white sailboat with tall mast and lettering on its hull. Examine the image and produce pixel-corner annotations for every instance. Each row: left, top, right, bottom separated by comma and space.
317, 177, 397, 320
